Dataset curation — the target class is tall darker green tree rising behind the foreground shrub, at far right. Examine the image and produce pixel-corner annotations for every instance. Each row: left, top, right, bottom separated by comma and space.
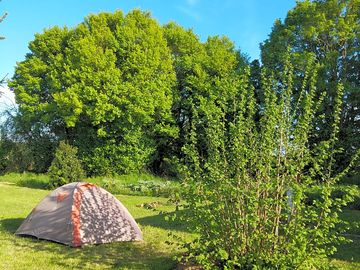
261, 0, 360, 172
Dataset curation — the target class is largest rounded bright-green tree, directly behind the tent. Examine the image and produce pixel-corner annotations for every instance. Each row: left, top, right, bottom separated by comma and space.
9, 10, 177, 174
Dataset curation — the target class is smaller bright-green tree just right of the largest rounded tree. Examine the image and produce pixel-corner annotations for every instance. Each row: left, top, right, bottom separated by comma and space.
164, 23, 247, 175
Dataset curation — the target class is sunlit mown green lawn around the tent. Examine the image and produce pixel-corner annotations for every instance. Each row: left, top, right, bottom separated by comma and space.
0, 177, 360, 270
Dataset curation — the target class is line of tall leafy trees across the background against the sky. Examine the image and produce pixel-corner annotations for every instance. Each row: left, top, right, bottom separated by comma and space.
0, 1, 360, 176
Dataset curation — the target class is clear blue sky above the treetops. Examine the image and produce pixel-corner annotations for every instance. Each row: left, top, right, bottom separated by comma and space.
0, 0, 296, 106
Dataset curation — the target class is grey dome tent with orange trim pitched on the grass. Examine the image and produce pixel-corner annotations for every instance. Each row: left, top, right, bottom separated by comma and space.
15, 182, 142, 247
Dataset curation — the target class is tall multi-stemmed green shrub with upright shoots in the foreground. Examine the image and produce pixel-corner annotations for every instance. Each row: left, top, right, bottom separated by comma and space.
179, 54, 355, 269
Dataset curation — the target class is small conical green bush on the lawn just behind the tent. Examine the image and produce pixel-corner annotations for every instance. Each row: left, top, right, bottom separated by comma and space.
49, 141, 85, 188
